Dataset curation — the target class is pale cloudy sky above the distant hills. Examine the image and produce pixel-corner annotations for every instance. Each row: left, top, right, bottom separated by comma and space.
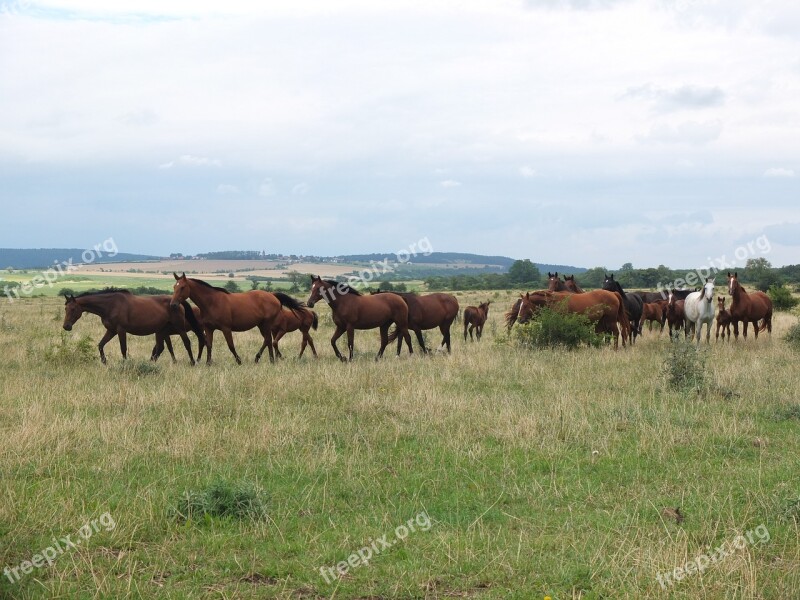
0, 0, 800, 269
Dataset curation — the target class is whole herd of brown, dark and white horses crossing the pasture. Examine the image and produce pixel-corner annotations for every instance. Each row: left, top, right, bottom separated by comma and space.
63, 273, 772, 365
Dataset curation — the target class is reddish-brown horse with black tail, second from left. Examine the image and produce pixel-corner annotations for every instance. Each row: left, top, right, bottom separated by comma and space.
172, 273, 302, 364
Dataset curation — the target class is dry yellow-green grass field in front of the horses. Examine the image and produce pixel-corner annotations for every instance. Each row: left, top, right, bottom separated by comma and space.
0, 292, 800, 600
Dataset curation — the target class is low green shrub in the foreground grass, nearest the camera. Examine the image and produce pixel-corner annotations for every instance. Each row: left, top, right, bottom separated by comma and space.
169, 479, 267, 521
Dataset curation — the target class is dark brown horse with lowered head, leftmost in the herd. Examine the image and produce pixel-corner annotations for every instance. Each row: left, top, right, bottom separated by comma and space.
62, 290, 206, 365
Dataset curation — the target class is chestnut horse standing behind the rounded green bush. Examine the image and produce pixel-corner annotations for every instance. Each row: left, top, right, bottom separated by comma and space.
517, 290, 630, 349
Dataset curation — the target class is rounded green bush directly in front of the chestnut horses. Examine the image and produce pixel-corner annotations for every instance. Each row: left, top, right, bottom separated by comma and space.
514, 307, 602, 350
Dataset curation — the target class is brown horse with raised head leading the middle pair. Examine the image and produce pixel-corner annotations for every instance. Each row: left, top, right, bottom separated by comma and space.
306, 275, 414, 362
